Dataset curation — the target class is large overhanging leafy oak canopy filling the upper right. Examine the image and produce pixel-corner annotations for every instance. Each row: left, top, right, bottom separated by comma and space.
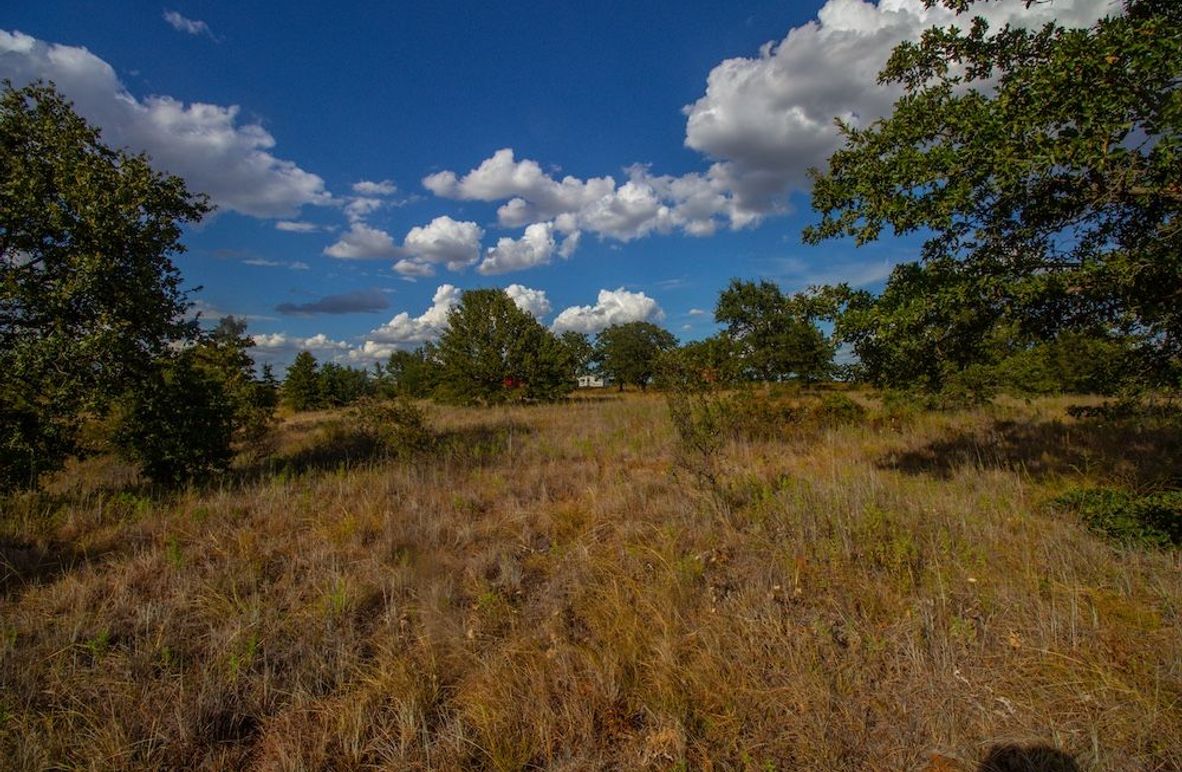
805, 0, 1182, 387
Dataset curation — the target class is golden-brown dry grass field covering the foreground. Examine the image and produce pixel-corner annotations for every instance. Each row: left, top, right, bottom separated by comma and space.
0, 394, 1182, 771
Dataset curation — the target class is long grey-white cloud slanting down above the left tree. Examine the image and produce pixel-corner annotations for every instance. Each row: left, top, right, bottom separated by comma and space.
0, 30, 332, 218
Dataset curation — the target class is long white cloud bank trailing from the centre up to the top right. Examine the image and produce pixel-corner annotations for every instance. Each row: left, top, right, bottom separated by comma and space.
422, 0, 1119, 255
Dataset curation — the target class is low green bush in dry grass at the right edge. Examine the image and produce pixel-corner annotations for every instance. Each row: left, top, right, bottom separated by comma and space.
1054, 488, 1182, 547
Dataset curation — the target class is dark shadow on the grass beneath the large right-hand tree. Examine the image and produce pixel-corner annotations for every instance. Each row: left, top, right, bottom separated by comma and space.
878, 411, 1182, 489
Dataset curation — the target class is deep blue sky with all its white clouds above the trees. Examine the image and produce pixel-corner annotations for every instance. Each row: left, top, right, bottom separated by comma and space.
0, 0, 1111, 364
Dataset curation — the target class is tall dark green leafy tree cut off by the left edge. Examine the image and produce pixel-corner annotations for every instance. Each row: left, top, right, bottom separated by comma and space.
0, 83, 210, 487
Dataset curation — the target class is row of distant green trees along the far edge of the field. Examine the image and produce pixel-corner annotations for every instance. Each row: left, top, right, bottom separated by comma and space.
281, 274, 1153, 410
